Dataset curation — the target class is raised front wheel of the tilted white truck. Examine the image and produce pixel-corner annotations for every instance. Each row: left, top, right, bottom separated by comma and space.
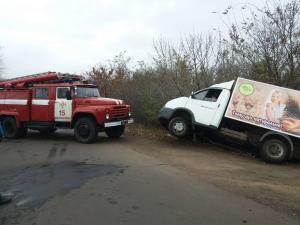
168, 117, 190, 138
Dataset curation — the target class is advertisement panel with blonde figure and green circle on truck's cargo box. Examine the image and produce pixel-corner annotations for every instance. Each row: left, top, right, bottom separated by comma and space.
225, 78, 300, 137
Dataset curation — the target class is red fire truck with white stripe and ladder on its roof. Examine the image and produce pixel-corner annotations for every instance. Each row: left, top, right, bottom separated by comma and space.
0, 72, 133, 143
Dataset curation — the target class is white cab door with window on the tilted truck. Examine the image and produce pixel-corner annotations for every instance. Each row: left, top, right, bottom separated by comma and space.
186, 88, 230, 127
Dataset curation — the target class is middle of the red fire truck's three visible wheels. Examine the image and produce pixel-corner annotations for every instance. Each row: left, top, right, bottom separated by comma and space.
74, 117, 98, 144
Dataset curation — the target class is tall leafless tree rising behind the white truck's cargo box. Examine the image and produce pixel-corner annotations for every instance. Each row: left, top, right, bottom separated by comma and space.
230, 0, 300, 86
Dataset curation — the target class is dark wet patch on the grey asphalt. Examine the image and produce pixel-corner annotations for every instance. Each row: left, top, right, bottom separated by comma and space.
0, 161, 125, 208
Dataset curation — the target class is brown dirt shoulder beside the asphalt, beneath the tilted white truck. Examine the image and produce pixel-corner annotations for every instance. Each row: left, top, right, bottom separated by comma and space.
127, 127, 300, 220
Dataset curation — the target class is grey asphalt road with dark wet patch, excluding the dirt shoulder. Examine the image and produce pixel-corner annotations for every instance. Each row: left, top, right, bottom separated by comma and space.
0, 131, 300, 225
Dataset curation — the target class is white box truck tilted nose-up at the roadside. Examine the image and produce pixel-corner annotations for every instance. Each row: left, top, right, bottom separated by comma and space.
158, 78, 300, 163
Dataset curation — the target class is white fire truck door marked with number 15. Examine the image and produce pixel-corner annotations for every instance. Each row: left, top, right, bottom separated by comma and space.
54, 87, 72, 122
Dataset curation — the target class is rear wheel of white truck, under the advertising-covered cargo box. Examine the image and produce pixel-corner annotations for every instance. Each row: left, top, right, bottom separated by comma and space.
260, 139, 289, 163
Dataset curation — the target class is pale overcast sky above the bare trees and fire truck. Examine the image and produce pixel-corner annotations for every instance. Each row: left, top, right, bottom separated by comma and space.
0, 0, 262, 77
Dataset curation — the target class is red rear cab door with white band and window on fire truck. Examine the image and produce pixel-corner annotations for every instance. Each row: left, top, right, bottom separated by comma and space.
31, 87, 51, 121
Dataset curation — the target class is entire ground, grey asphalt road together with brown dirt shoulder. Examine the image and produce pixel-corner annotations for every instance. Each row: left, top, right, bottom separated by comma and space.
0, 131, 300, 225
